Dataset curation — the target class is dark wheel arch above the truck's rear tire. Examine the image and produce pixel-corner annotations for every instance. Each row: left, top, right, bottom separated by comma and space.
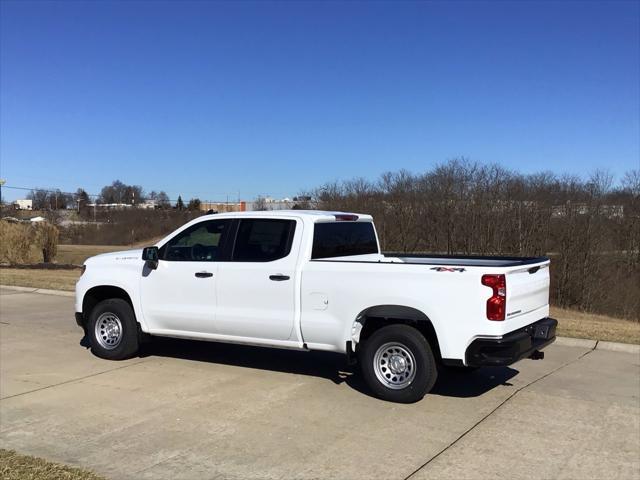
351, 305, 442, 360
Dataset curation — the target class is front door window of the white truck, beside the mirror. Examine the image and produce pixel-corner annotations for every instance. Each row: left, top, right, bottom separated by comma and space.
160, 220, 230, 262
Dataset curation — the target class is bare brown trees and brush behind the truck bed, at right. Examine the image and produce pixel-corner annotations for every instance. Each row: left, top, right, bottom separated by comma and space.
310, 160, 640, 320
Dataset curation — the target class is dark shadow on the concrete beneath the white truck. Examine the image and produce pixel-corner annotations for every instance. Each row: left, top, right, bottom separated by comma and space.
80, 337, 518, 398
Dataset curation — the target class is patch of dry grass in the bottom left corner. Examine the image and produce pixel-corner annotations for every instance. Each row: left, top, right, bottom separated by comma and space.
0, 449, 104, 480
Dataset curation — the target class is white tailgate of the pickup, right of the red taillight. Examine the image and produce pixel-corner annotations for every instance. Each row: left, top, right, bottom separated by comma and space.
506, 260, 549, 320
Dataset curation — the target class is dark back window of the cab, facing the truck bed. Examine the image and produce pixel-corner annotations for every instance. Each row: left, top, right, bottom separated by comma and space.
311, 222, 378, 259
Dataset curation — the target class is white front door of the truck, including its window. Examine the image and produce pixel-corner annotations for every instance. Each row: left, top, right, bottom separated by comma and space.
140, 220, 231, 334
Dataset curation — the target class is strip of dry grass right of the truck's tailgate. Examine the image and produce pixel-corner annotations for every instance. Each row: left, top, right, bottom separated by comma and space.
551, 307, 640, 344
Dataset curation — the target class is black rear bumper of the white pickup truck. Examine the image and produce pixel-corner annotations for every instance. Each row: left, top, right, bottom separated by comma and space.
465, 317, 558, 367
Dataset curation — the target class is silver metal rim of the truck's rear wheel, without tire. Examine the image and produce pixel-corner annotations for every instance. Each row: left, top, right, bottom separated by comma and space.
373, 342, 416, 390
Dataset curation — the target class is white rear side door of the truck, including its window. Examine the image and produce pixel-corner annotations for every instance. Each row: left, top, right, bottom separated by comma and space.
216, 218, 302, 340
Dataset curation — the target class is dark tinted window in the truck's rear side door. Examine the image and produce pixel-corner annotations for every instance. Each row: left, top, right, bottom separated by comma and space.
233, 219, 296, 262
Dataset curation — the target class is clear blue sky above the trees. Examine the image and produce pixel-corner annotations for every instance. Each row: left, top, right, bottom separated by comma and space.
0, 0, 640, 199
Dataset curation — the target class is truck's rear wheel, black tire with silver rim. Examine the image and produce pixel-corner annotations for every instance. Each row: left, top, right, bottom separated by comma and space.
359, 324, 438, 403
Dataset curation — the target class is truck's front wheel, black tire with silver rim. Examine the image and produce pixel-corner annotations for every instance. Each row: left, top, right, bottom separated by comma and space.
87, 298, 138, 360
